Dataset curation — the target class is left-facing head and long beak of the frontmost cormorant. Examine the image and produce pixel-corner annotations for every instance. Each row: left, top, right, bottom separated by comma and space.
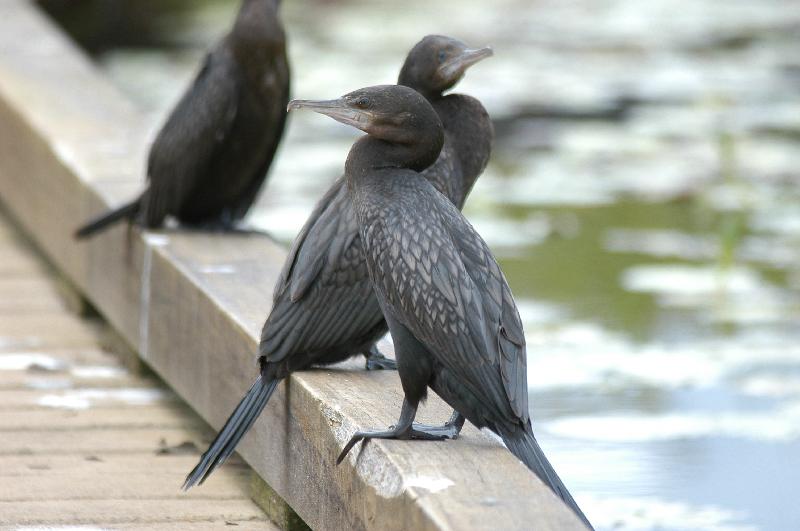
287, 85, 444, 171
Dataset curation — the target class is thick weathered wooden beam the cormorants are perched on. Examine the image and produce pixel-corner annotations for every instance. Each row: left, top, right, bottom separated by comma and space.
0, 0, 582, 530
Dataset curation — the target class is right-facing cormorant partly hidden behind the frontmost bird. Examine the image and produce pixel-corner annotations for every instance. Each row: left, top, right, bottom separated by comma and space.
184, 36, 494, 489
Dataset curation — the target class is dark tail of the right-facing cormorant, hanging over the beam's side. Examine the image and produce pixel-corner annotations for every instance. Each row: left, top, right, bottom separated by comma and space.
183, 375, 278, 490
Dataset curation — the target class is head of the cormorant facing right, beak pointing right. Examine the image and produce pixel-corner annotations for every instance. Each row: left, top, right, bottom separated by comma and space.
397, 35, 493, 97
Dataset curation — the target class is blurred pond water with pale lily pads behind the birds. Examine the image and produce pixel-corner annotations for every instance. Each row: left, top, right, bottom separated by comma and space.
50, 0, 800, 529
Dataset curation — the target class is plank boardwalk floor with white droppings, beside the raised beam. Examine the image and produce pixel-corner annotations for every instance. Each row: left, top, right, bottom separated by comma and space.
0, 213, 277, 530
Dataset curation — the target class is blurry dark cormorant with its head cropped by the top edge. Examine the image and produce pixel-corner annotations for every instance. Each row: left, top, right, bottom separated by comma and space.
76, 0, 289, 238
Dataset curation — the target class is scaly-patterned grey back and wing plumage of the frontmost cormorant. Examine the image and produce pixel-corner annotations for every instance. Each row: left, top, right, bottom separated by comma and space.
354, 170, 528, 427
